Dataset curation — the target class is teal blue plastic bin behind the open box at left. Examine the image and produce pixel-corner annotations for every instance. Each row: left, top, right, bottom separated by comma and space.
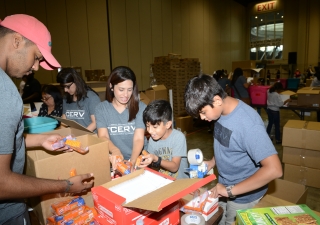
23, 117, 58, 134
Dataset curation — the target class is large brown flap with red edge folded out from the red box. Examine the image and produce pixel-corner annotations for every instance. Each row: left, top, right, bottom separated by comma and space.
123, 174, 216, 212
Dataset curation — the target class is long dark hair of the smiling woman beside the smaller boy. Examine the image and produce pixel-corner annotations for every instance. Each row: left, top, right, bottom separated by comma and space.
106, 66, 139, 122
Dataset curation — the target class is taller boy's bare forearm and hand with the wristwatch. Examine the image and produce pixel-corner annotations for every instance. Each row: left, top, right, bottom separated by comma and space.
211, 154, 282, 198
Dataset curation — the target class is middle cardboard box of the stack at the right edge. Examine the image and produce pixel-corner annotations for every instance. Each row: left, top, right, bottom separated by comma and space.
282, 146, 320, 169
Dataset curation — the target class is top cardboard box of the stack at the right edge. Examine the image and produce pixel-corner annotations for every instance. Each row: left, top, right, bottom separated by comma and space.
282, 120, 320, 151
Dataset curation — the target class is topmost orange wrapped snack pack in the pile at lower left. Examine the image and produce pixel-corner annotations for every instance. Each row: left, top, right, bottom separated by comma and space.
51, 197, 85, 215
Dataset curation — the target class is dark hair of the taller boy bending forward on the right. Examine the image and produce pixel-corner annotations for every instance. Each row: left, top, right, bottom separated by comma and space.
184, 74, 228, 117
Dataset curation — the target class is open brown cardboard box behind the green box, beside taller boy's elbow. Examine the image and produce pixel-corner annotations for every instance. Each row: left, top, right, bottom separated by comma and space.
261, 179, 308, 205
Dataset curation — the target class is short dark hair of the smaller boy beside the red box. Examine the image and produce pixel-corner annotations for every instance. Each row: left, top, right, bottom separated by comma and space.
143, 100, 172, 125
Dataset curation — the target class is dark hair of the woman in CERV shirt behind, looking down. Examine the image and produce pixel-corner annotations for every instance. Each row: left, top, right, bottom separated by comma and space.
57, 68, 99, 103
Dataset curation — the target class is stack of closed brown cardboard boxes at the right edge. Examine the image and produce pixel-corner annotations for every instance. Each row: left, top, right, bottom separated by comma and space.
282, 120, 320, 188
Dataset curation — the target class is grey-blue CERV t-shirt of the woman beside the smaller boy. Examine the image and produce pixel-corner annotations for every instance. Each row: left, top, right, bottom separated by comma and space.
95, 101, 147, 160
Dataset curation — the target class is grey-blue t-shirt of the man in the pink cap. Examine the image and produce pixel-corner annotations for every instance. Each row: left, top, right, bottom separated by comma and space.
0, 68, 26, 224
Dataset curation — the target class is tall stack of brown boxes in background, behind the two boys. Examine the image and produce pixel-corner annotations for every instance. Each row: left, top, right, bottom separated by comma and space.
151, 53, 201, 132
